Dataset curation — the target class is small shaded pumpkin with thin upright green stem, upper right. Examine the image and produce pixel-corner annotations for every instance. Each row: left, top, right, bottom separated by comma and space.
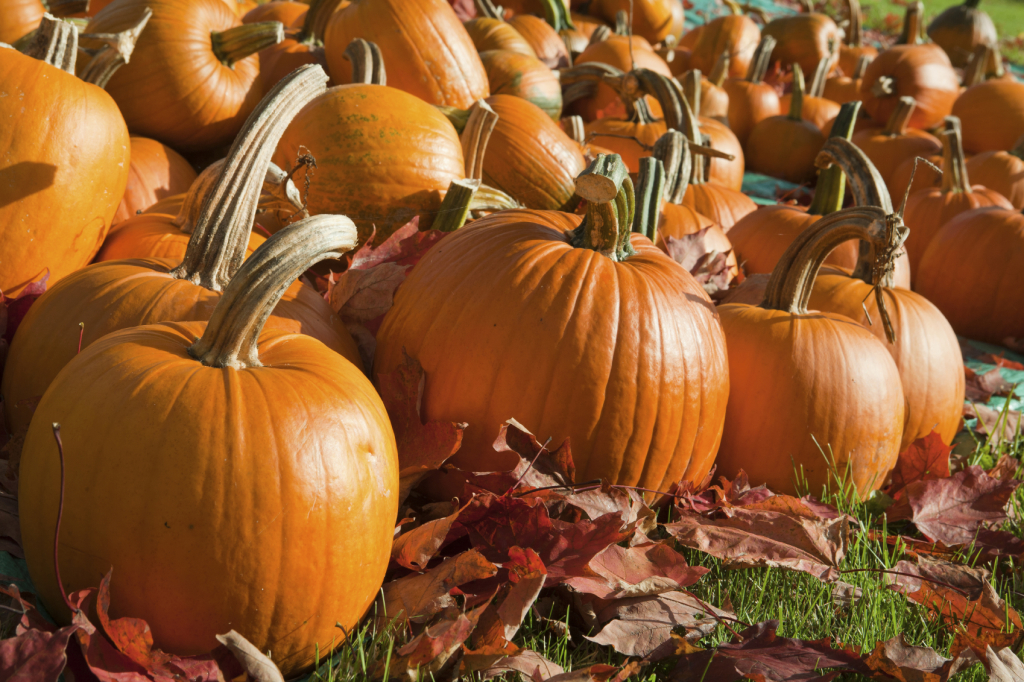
745, 63, 825, 183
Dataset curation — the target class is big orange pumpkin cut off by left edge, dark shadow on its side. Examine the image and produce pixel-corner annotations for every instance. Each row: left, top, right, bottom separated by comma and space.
0, 17, 130, 297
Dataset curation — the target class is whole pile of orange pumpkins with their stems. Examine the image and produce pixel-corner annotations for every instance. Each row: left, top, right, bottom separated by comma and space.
0, 0, 1024, 674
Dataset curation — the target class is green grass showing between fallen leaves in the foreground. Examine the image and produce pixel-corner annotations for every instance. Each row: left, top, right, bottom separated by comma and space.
309, 421, 1024, 682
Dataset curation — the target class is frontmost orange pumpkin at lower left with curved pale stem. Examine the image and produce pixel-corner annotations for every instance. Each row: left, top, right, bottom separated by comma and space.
19, 210, 398, 676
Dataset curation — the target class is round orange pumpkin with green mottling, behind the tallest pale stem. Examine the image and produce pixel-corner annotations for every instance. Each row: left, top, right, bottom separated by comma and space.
273, 41, 464, 242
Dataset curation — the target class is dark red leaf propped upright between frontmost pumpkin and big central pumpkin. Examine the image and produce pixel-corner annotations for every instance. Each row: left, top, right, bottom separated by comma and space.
377, 355, 466, 504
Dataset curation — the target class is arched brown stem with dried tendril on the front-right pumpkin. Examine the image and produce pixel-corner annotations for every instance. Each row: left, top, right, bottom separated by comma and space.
761, 201, 909, 343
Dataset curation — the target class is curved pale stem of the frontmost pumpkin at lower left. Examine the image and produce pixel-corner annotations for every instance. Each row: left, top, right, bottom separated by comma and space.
188, 215, 358, 370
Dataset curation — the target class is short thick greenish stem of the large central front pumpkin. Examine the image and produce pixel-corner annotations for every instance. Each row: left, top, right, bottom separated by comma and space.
571, 154, 634, 260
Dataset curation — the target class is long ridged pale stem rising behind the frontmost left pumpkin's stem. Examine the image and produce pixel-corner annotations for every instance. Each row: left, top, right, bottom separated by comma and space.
171, 65, 328, 291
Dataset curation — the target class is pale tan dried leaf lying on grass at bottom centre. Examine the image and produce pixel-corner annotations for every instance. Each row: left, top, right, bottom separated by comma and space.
587, 592, 733, 660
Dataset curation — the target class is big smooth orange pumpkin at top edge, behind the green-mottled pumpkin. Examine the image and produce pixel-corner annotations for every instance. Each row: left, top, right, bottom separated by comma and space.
325, 0, 490, 108
